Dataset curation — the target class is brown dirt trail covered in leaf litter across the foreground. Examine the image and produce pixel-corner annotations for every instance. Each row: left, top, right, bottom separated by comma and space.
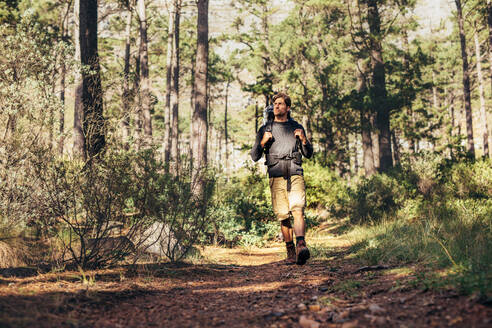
0, 240, 492, 328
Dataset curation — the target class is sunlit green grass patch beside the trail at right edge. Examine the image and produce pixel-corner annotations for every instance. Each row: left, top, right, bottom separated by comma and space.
347, 199, 492, 295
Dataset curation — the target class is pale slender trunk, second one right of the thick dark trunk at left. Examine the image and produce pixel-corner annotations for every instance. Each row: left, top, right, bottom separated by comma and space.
137, 0, 152, 146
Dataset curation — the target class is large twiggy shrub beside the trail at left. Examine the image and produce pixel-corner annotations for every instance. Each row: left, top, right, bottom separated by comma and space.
2, 144, 213, 268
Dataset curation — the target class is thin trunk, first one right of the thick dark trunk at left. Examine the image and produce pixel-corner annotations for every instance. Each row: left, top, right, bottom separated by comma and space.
121, 4, 133, 144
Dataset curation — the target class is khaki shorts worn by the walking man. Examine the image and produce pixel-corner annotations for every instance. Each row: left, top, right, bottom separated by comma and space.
270, 175, 306, 221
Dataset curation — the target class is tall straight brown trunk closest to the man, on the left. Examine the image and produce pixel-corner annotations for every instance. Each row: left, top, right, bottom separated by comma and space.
192, 0, 208, 188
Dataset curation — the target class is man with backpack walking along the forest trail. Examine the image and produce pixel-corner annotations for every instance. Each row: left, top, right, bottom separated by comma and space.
251, 93, 313, 265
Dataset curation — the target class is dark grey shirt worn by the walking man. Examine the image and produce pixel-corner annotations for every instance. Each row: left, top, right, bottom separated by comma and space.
251, 119, 313, 177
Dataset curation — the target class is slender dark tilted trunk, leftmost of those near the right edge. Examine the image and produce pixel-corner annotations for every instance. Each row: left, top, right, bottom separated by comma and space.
455, 0, 475, 158
